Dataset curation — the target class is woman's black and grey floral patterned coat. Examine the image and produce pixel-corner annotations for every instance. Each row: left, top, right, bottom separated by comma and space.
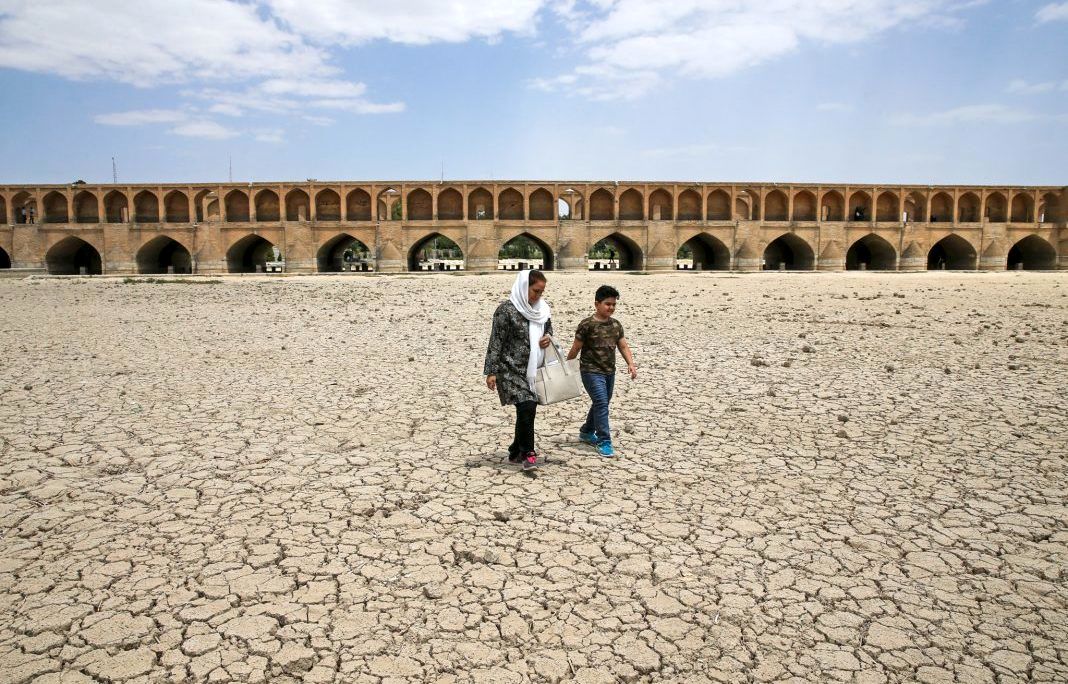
483, 301, 552, 406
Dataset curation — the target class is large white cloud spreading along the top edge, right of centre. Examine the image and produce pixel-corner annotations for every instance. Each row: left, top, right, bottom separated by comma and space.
531, 0, 970, 98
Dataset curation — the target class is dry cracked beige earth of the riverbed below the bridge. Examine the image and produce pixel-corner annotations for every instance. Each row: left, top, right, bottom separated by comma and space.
0, 273, 1068, 684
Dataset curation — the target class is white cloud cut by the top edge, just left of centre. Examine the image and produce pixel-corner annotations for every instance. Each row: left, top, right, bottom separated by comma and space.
259, 0, 543, 45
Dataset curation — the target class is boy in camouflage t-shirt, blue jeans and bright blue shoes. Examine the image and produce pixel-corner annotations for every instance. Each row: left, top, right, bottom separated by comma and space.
567, 285, 638, 457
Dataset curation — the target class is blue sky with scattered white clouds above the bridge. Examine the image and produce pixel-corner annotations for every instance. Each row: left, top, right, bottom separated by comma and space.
0, 0, 1068, 186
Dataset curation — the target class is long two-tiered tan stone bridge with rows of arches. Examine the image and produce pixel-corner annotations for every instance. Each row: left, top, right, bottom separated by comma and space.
0, 181, 1068, 275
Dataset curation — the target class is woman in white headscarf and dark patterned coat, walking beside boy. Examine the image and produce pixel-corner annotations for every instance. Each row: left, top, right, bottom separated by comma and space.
483, 270, 552, 470
